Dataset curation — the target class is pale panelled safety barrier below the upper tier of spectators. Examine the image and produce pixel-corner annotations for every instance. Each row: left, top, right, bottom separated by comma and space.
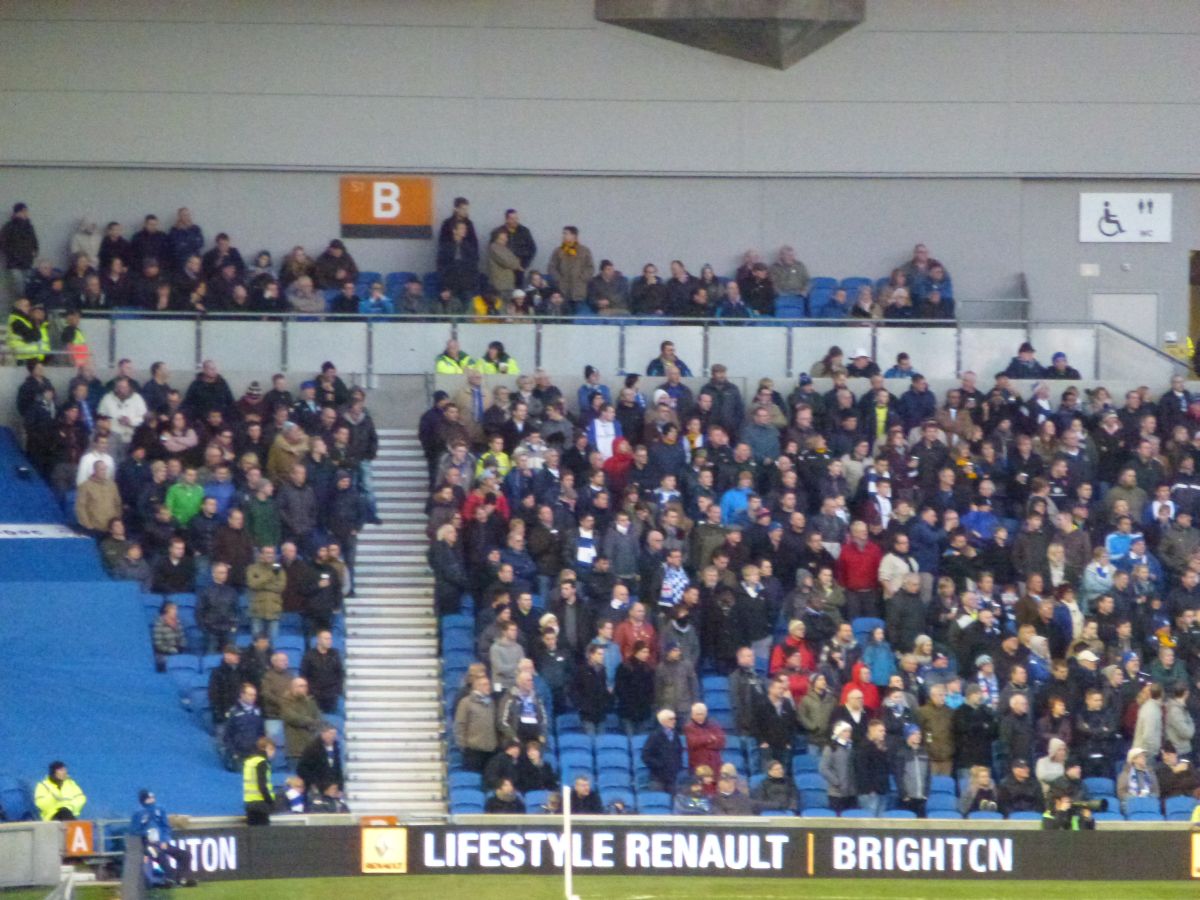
83, 312, 1188, 384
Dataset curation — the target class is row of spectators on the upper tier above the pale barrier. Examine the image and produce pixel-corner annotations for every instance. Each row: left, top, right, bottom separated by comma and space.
0, 197, 954, 348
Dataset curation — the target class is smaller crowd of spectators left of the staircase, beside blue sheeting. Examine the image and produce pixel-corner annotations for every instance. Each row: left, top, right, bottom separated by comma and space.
17, 360, 369, 808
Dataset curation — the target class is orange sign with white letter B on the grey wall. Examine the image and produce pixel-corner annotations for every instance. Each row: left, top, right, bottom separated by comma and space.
341, 175, 433, 238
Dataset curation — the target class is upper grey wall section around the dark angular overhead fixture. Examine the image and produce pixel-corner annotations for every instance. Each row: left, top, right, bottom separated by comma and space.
0, 0, 1200, 176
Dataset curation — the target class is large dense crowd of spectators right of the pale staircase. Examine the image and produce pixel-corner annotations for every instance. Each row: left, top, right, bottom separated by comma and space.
432, 342, 1200, 827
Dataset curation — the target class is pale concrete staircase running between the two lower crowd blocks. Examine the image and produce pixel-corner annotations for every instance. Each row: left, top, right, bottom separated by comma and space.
346, 428, 446, 816
